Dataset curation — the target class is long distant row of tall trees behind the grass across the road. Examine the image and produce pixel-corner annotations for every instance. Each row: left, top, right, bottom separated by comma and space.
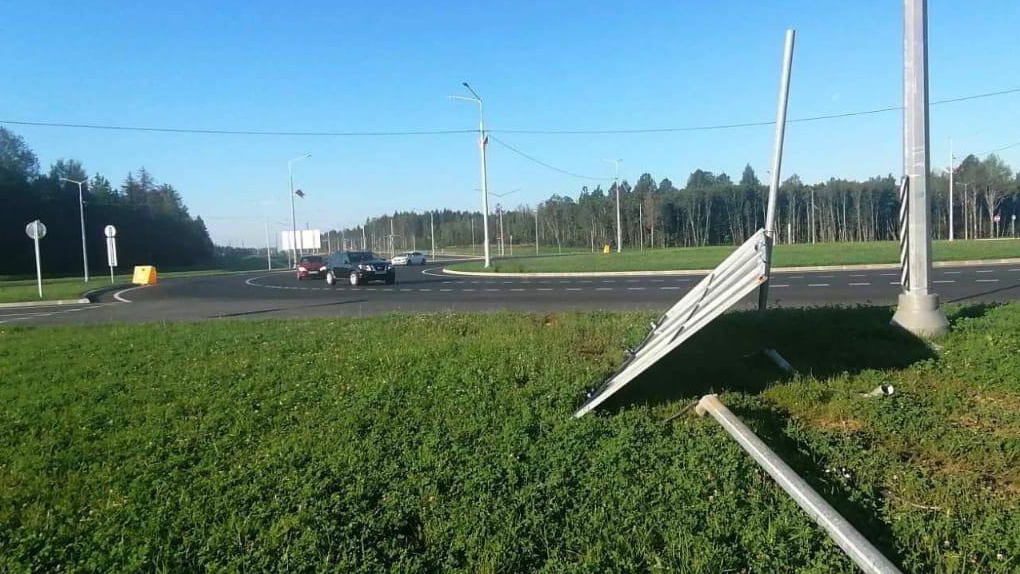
336, 155, 1020, 253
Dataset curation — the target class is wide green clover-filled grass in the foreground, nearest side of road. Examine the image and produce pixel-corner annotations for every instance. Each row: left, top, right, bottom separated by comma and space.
0, 305, 1020, 573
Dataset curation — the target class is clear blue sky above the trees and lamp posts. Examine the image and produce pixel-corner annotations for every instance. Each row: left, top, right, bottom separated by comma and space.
0, 0, 1020, 245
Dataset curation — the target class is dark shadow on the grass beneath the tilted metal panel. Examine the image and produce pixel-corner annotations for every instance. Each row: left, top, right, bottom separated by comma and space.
602, 307, 934, 411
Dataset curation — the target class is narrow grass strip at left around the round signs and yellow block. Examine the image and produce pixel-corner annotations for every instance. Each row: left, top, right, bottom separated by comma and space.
0, 256, 287, 303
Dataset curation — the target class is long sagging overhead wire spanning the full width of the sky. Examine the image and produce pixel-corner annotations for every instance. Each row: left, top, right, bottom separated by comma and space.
0, 88, 1020, 138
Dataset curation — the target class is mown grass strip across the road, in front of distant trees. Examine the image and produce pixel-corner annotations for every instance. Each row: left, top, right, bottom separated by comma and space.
450, 240, 1020, 273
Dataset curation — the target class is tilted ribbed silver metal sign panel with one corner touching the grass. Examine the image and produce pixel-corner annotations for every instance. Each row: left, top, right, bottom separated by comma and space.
573, 229, 768, 418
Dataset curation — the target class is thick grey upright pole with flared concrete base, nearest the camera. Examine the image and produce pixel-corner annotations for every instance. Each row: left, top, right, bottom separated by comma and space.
893, 0, 950, 336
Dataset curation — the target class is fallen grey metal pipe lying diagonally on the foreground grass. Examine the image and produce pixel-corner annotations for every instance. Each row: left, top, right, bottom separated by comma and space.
696, 395, 902, 574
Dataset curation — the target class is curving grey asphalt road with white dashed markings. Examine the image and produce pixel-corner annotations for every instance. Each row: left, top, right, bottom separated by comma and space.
0, 258, 1020, 324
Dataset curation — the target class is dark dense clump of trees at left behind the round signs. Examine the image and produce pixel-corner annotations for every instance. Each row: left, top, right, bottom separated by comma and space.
0, 127, 213, 275
